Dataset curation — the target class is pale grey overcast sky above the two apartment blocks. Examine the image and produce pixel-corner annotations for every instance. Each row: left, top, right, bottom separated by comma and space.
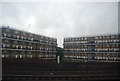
0, 2, 118, 47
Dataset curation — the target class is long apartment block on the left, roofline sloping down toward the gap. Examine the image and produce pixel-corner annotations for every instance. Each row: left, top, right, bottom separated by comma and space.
0, 26, 57, 59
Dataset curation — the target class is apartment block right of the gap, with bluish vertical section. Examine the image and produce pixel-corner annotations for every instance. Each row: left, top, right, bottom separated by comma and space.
63, 34, 120, 62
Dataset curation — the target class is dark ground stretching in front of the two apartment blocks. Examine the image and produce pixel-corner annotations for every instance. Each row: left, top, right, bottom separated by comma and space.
2, 59, 120, 81
